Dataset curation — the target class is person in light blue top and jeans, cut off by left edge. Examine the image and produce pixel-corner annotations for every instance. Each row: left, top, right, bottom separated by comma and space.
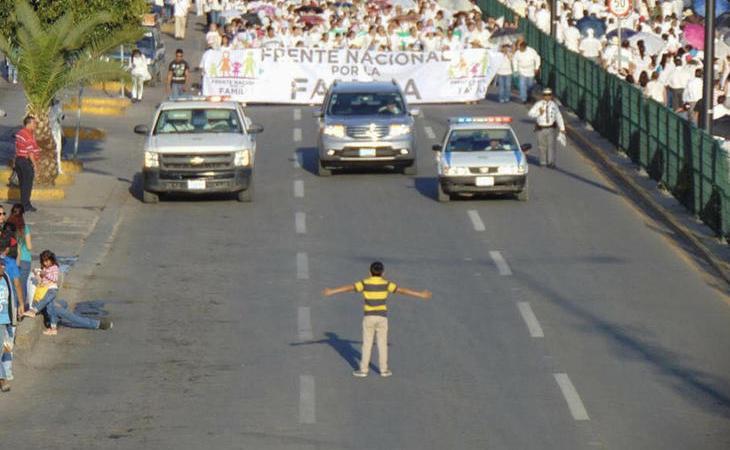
0, 258, 19, 392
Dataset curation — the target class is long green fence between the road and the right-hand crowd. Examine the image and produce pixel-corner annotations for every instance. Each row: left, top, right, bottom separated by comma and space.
479, 0, 730, 236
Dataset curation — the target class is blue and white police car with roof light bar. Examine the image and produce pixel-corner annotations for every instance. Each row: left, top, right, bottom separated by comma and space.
433, 116, 532, 202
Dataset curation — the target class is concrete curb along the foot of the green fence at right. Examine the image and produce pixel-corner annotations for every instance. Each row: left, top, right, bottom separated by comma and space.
565, 123, 730, 284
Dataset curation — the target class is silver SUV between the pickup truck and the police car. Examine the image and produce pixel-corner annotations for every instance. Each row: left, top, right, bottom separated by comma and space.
315, 81, 419, 176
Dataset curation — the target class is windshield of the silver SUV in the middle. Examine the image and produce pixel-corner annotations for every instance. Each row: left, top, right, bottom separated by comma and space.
327, 92, 406, 116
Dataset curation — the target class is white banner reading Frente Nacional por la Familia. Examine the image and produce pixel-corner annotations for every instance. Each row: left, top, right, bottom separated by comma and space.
201, 48, 504, 104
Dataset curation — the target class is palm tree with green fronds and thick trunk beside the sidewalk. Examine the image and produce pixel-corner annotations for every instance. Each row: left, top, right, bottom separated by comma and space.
0, 0, 140, 186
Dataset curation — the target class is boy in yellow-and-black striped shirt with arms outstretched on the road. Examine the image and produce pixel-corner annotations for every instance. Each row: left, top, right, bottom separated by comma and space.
323, 261, 431, 377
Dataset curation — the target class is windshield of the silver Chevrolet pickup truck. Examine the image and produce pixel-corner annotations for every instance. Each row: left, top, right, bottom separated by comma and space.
154, 108, 241, 134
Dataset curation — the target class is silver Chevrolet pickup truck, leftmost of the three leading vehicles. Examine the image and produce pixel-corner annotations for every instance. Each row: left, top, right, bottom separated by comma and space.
134, 99, 263, 203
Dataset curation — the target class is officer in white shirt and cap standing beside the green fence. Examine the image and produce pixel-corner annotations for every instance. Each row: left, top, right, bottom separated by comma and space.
527, 88, 566, 168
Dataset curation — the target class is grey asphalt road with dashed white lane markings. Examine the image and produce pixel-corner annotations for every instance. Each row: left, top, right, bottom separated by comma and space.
0, 15, 730, 449
